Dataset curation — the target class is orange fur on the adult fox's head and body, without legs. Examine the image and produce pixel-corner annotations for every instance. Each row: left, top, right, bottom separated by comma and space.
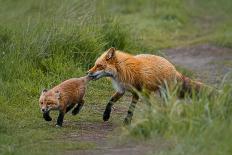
89, 47, 190, 91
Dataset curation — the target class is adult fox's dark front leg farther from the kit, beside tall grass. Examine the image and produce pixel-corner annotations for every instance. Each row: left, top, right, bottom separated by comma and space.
123, 92, 139, 125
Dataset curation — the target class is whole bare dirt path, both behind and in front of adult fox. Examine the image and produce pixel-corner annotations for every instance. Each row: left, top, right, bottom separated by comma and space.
65, 45, 232, 155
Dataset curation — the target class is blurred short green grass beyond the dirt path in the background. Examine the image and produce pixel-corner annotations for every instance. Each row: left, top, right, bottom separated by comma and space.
101, 0, 232, 49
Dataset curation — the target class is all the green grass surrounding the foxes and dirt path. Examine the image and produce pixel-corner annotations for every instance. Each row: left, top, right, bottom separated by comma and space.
0, 0, 232, 154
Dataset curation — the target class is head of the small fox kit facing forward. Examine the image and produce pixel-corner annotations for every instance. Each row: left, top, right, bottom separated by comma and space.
39, 89, 61, 113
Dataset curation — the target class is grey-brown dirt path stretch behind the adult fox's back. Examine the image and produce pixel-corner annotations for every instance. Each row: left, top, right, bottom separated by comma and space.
164, 44, 232, 84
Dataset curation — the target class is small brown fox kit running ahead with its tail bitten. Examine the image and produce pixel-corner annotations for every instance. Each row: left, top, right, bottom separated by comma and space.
39, 76, 90, 127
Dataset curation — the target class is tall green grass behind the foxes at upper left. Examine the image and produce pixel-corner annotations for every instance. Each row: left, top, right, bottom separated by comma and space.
0, 0, 149, 96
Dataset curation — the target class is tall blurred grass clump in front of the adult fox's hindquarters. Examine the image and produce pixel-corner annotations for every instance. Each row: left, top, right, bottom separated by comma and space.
126, 77, 232, 155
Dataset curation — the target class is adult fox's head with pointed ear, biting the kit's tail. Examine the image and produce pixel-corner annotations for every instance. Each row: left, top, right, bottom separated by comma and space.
88, 47, 117, 80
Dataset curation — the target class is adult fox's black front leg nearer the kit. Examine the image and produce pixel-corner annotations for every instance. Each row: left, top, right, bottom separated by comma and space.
103, 91, 125, 121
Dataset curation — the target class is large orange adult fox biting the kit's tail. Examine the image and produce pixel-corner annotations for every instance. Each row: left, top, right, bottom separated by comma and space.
88, 48, 201, 124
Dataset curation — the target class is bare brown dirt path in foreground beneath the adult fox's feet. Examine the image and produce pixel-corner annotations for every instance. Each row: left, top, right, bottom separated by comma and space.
64, 106, 167, 155
